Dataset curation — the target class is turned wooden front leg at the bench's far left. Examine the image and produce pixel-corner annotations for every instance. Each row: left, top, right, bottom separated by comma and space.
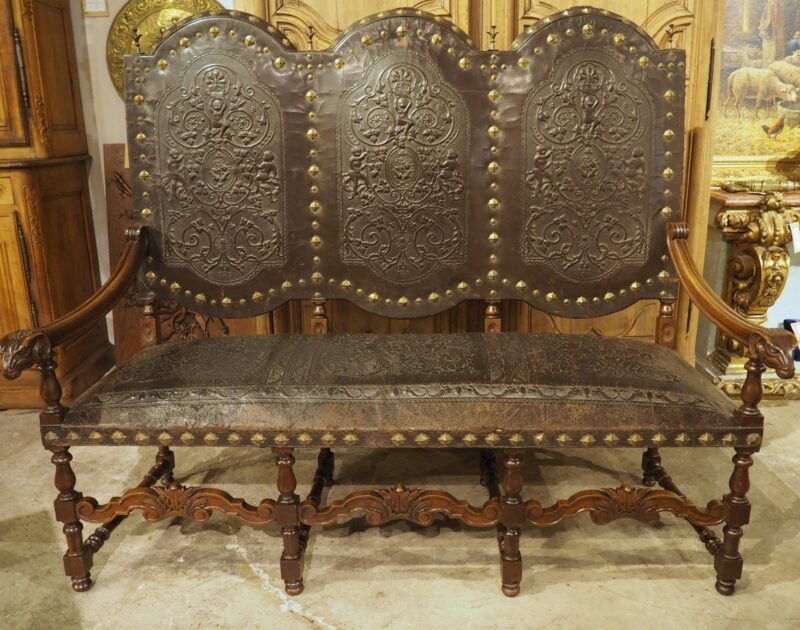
51, 447, 92, 592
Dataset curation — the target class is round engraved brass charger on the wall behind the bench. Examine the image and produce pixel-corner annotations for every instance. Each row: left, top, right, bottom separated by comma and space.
106, 0, 225, 97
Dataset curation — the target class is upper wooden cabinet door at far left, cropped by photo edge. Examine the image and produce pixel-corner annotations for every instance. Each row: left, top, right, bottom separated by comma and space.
0, 0, 28, 146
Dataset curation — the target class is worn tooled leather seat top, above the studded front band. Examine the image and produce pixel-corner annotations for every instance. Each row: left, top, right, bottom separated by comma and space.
67, 333, 733, 426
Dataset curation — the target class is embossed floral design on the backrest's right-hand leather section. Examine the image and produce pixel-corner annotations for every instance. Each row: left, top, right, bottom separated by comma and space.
522, 50, 652, 282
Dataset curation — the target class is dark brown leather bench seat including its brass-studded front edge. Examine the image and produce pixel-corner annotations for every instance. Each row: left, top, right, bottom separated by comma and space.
53, 333, 748, 446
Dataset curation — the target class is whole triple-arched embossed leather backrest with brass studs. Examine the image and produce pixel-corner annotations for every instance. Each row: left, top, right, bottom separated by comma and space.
125, 8, 685, 317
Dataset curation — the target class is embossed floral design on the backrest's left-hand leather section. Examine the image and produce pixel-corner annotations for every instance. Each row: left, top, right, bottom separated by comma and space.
158, 55, 285, 285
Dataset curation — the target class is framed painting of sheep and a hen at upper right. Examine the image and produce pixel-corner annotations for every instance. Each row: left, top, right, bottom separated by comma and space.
714, 0, 800, 183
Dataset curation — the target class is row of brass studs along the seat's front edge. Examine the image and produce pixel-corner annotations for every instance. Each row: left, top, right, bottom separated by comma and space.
43, 430, 761, 447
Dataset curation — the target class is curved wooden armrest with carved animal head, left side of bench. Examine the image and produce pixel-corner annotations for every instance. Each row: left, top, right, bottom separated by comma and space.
0, 226, 147, 379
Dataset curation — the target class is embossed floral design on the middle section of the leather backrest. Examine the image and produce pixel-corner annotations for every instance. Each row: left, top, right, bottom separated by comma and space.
338, 53, 468, 282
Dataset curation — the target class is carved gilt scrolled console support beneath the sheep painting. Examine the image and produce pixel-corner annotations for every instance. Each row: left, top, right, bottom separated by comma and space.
709, 190, 800, 397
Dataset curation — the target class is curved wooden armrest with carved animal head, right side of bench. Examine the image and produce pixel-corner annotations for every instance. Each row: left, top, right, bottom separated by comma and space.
667, 223, 797, 378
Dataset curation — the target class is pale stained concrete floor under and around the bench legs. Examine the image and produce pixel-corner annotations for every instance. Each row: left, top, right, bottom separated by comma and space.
0, 402, 800, 630
